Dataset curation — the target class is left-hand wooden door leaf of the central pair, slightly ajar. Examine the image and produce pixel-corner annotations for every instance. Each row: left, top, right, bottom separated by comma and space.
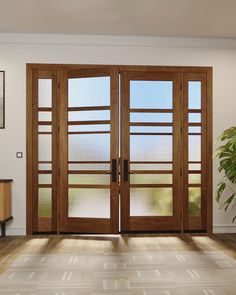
60, 67, 119, 233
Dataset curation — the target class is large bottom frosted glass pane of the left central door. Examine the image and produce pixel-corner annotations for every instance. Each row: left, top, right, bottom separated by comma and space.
68, 189, 110, 218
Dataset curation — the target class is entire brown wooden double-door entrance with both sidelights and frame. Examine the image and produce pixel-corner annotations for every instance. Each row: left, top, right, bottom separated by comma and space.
27, 64, 212, 234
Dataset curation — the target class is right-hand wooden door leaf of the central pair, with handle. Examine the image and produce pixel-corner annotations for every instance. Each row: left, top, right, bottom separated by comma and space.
121, 72, 182, 231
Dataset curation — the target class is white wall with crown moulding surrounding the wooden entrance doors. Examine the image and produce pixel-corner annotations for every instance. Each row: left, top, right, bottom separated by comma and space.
0, 34, 236, 235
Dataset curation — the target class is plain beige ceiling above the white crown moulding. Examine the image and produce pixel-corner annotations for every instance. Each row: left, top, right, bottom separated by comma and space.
0, 0, 236, 38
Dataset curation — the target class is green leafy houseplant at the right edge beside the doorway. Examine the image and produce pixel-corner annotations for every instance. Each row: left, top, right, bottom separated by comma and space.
216, 126, 236, 222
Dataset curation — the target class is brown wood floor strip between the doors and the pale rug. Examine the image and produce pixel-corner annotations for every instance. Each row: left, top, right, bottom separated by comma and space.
0, 234, 236, 273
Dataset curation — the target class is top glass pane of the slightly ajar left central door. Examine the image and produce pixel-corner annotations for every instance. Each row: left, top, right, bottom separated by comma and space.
68, 77, 110, 107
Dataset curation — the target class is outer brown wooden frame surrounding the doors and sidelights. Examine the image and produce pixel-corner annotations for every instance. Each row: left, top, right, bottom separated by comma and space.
26, 63, 213, 235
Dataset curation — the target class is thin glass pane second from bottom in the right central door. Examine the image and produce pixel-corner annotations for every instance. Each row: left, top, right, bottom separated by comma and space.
130, 174, 173, 184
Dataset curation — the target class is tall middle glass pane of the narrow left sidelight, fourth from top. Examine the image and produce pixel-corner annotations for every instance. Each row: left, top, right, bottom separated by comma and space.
38, 135, 52, 161
